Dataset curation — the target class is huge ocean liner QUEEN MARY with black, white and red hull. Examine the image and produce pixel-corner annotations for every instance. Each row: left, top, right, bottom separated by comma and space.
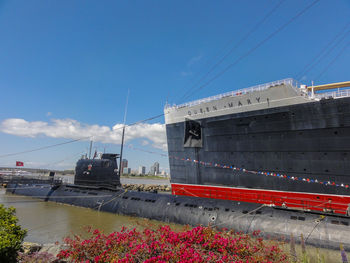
164, 79, 350, 214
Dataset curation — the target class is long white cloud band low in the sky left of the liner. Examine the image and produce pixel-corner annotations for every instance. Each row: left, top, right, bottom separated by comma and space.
0, 119, 167, 150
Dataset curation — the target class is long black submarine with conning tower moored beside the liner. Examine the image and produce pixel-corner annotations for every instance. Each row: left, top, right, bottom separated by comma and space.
6, 153, 350, 249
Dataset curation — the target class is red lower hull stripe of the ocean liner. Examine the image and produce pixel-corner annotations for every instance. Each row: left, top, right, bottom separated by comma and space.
171, 184, 350, 214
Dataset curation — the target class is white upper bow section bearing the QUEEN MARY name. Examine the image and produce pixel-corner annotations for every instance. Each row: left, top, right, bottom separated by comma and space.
164, 78, 350, 124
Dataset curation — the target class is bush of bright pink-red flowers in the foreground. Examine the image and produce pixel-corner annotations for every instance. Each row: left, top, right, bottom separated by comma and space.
57, 226, 289, 263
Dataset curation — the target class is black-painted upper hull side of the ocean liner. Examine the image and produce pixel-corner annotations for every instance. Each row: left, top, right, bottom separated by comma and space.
166, 98, 350, 214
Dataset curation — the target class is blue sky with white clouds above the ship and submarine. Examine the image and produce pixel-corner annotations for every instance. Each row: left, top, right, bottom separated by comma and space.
0, 0, 350, 172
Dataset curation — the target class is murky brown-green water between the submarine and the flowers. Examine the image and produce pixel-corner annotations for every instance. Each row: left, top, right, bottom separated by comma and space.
0, 189, 182, 243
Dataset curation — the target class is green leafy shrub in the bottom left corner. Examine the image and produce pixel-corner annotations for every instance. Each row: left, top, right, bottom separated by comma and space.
0, 204, 27, 263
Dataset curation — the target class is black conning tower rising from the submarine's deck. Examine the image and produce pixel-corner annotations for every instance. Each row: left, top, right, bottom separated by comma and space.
74, 153, 121, 189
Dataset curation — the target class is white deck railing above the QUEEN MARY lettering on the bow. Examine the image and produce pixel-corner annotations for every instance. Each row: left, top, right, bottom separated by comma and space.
165, 78, 299, 109
